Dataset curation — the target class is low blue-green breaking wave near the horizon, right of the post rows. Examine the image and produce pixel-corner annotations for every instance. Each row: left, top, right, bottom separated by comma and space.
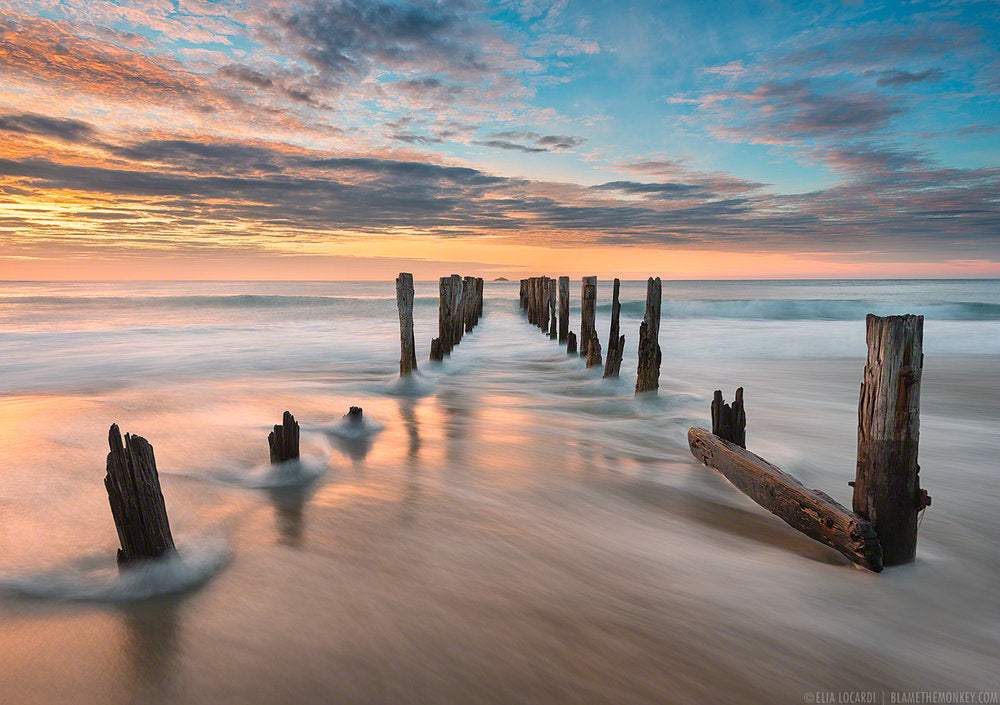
598, 299, 1000, 321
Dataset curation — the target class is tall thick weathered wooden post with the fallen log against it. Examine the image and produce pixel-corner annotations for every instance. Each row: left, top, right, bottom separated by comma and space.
853, 314, 931, 565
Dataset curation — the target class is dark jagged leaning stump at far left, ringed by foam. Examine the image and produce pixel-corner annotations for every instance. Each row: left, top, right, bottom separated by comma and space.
104, 424, 174, 568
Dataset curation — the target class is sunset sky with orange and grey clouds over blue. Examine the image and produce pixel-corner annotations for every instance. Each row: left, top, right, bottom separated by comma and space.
0, 0, 1000, 280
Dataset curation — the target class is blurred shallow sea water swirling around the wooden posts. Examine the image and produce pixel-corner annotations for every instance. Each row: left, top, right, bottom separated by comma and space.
0, 281, 1000, 704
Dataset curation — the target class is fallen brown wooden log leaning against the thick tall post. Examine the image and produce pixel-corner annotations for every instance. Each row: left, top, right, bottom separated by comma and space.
688, 428, 882, 573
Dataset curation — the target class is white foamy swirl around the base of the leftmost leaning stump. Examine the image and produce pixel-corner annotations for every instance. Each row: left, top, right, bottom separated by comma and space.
0, 538, 229, 602
